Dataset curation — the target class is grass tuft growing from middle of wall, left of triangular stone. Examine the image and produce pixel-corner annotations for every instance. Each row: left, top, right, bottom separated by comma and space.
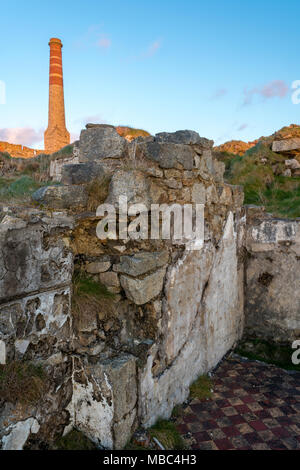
72, 272, 115, 315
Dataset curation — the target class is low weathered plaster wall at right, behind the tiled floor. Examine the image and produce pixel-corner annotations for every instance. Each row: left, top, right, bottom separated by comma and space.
245, 207, 300, 345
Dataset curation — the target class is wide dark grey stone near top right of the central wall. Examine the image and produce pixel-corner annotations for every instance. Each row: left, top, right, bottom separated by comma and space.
136, 142, 195, 170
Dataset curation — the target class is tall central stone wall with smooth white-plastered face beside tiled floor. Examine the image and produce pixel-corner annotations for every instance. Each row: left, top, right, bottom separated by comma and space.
28, 125, 243, 448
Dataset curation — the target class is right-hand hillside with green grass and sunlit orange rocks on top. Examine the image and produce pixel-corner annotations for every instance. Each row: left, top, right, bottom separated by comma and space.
215, 124, 300, 218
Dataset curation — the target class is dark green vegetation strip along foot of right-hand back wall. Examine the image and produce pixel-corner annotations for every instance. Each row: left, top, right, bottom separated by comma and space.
235, 338, 300, 371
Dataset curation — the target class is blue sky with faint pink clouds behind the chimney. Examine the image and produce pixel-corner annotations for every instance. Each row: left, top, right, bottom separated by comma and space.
0, 0, 300, 147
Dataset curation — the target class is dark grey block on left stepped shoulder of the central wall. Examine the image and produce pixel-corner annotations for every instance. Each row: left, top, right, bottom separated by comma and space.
61, 162, 105, 185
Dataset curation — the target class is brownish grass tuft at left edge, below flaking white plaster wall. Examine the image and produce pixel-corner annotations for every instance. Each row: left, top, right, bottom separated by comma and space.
0, 361, 47, 404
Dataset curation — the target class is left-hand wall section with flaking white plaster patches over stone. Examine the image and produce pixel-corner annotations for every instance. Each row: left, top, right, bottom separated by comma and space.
0, 210, 73, 450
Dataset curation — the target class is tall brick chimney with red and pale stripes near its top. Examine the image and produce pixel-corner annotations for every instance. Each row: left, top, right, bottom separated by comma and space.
44, 38, 70, 153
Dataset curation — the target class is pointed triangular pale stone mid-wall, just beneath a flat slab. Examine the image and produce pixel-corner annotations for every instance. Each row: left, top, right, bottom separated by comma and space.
120, 268, 166, 305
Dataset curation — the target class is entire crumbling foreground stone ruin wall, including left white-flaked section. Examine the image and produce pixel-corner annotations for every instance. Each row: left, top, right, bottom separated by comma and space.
0, 126, 299, 449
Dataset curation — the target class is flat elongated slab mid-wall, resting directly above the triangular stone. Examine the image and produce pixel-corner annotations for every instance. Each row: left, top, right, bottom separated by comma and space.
116, 251, 169, 277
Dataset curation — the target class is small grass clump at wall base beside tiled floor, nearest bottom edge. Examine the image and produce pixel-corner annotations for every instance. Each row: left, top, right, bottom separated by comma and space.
149, 420, 186, 450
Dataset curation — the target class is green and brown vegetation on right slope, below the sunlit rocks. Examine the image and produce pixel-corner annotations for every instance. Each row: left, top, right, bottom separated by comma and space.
219, 140, 300, 218
